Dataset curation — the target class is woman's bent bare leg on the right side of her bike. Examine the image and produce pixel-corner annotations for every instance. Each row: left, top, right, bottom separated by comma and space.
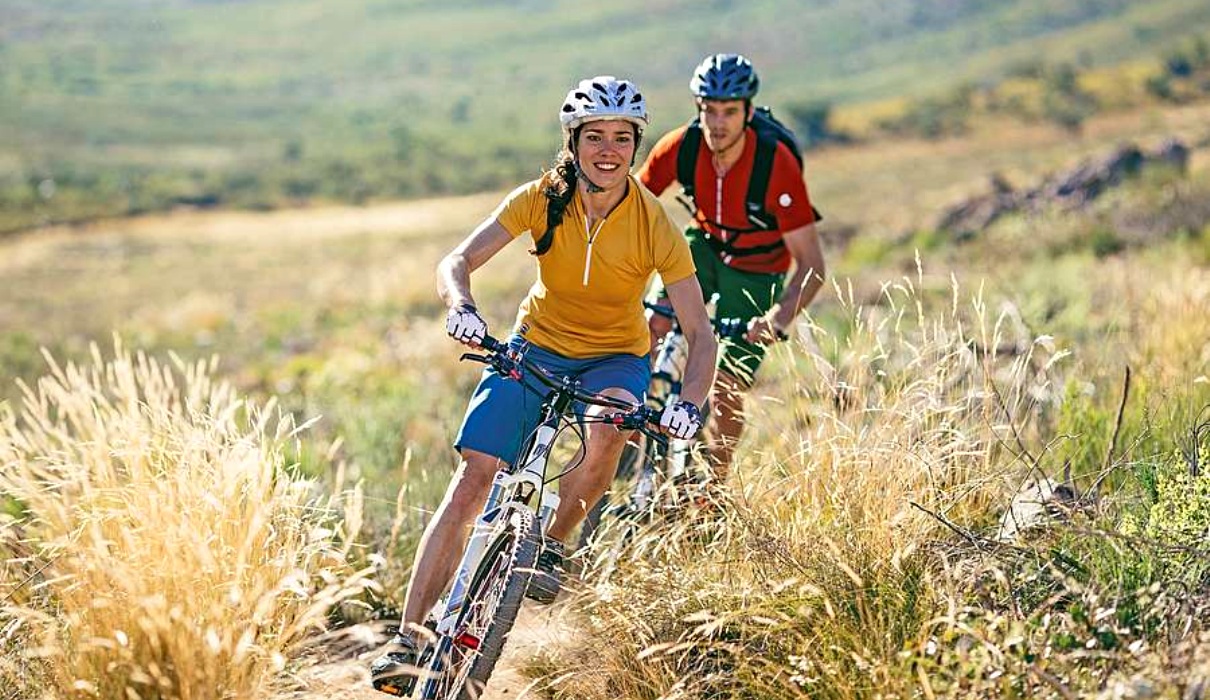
547, 389, 638, 542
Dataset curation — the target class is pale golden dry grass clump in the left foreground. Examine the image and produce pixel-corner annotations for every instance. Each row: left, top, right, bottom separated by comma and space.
0, 346, 369, 700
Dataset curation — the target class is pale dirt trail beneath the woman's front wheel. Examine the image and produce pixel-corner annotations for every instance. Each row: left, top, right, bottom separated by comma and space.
289, 601, 571, 700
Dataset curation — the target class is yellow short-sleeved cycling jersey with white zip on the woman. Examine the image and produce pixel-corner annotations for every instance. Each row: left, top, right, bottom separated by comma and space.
494, 174, 695, 359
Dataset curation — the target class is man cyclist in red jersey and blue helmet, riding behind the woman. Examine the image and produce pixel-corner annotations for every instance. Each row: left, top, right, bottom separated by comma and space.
639, 53, 824, 485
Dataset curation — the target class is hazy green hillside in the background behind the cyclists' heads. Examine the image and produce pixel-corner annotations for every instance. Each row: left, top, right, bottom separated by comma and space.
0, 0, 1210, 231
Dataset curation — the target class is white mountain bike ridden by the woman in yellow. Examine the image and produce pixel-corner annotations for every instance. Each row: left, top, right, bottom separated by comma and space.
411, 336, 663, 700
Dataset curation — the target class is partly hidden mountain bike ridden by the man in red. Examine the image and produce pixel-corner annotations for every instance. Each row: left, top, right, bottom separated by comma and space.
578, 301, 748, 549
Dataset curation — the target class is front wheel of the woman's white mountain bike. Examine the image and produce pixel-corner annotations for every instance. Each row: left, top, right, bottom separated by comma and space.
434, 509, 541, 700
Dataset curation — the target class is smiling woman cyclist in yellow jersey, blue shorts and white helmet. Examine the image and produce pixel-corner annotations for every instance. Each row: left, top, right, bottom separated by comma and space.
370, 76, 718, 695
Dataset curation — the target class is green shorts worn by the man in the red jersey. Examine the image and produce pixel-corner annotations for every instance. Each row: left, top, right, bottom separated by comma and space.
663, 228, 785, 388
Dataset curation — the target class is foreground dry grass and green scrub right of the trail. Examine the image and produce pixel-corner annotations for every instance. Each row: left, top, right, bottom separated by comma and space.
529, 264, 1210, 700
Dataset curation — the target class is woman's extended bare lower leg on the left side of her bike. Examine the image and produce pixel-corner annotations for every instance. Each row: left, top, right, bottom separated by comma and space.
401, 450, 499, 630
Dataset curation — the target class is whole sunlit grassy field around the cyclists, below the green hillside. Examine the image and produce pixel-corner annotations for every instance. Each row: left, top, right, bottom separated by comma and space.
0, 96, 1210, 700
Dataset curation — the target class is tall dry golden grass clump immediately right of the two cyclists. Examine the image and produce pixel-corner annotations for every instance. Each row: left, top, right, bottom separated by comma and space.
529, 270, 1040, 699
